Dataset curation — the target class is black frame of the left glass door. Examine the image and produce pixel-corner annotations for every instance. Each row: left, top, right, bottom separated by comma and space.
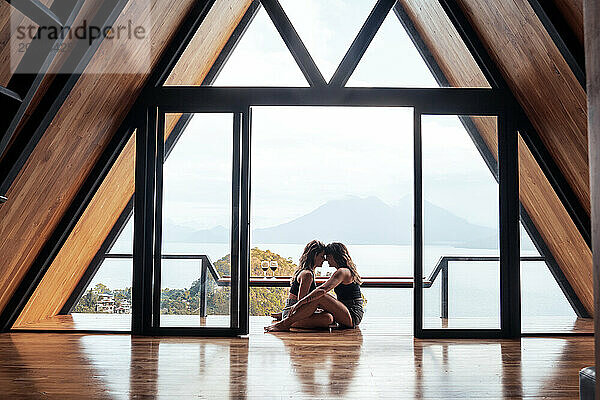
132, 107, 250, 336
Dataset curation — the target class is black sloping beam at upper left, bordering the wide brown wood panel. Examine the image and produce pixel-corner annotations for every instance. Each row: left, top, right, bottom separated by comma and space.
0, 0, 127, 197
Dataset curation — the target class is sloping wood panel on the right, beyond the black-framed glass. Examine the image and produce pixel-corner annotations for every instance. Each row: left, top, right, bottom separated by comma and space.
401, 0, 593, 314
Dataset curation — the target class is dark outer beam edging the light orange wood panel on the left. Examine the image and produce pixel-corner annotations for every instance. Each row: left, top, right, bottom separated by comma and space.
59, 0, 260, 315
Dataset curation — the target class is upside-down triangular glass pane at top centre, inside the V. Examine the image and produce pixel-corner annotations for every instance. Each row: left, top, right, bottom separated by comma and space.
280, 0, 375, 81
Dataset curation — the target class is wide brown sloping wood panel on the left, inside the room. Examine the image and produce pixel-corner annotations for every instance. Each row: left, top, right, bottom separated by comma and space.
0, 0, 193, 318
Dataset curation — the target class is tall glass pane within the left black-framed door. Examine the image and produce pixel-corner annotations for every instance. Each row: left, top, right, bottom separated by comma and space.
160, 113, 233, 327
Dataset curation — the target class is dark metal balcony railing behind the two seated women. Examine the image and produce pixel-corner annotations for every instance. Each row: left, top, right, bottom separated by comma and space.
105, 253, 546, 319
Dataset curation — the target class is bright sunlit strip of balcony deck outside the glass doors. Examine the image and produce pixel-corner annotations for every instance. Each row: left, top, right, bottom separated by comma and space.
14, 313, 594, 335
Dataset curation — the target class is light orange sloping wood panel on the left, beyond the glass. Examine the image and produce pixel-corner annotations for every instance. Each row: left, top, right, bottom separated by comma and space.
15, 0, 251, 326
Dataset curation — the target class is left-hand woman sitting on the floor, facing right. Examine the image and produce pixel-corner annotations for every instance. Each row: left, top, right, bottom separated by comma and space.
271, 240, 331, 320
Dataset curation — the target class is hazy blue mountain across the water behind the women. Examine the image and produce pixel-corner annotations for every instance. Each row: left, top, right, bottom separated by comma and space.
164, 196, 498, 248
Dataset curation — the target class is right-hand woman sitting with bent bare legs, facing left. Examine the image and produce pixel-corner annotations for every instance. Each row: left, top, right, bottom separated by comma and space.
265, 243, 364, 332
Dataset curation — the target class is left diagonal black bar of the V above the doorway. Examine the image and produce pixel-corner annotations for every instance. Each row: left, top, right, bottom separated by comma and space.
261, 0, 327, 87
